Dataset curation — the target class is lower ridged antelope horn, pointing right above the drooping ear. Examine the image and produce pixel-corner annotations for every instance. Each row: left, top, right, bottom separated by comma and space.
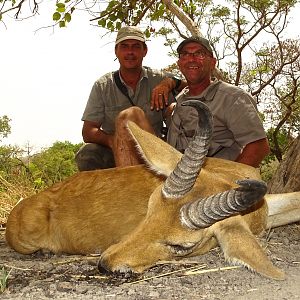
180, 179, 267, 229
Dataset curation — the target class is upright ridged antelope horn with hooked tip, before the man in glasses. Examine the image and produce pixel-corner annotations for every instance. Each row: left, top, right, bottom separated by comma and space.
162, 100, 213, 198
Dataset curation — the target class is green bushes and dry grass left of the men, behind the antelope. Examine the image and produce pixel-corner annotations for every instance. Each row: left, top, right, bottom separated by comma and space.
0, 142, 81, 224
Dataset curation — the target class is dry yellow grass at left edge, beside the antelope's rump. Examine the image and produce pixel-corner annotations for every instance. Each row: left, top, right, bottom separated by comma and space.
0, 175, 35, 226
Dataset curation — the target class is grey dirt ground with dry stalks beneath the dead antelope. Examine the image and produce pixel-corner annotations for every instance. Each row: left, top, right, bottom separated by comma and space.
0, 223, 300, 300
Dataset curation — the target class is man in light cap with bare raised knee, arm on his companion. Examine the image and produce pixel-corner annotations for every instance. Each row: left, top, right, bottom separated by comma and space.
75, 26, 181, 171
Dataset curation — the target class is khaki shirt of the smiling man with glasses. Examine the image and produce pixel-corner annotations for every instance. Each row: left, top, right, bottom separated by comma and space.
167, 80, 266, 160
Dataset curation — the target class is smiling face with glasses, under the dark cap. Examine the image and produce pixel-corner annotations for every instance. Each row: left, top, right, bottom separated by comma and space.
177, 42, 216, 84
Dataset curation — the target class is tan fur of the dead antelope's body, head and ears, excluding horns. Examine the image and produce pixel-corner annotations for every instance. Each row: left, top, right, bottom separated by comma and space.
6, 123, 300, 279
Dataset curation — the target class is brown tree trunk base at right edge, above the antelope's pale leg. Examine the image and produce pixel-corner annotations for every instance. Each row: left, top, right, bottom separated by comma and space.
268, 135, 300, 194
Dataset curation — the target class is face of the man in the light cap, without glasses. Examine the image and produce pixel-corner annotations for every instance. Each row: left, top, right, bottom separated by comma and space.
115, 40, 147, 69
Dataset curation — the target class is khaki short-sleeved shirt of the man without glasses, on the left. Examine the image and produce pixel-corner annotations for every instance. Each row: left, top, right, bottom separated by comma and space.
81, 67, 174, 135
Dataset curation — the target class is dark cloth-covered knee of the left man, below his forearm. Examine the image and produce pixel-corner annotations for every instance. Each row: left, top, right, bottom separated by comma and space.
75, 143, 115, 171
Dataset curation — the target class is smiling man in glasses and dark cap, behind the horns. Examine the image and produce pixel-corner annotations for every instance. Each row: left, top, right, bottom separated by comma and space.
167, 37, 270, 167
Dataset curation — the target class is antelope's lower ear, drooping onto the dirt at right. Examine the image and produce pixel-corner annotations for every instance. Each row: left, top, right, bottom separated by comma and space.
214, 216, 285, 280
